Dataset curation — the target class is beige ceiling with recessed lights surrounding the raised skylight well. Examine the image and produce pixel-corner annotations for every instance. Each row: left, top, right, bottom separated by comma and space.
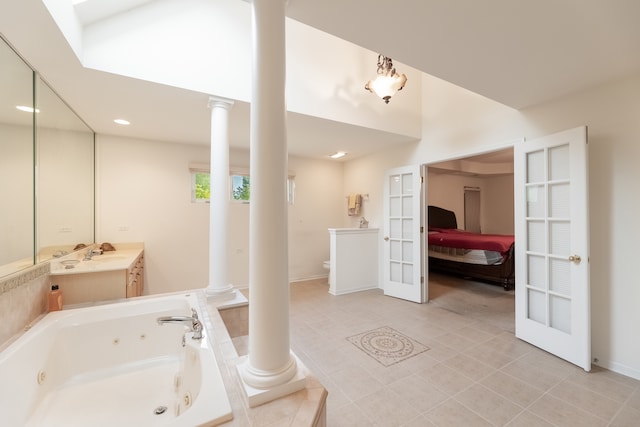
0, 0, 640, 160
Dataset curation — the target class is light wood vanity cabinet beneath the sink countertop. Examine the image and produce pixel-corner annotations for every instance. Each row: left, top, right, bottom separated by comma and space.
50, 250, 144, 307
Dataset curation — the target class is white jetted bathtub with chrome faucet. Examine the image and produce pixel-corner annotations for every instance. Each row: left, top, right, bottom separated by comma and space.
0, 294, 232, 427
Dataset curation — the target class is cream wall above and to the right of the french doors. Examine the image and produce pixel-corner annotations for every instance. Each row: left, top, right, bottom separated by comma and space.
344, 71, 640, 379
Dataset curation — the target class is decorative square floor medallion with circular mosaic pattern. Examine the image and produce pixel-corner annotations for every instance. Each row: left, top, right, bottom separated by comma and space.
347, 326, 429, 366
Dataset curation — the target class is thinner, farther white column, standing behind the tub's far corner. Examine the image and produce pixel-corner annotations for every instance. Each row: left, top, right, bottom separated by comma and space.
205, 96, 235, 297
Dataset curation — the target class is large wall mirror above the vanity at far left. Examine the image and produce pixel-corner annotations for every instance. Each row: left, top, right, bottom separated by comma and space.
0, 38, 95, 277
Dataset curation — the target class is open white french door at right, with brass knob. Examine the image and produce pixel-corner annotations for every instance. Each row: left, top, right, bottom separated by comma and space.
514, 127, 591, 371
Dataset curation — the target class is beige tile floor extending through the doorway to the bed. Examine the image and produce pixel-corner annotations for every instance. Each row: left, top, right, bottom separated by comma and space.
290, 273, 640, 427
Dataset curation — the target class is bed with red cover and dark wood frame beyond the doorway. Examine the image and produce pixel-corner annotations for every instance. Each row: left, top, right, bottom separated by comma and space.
428, 206, 515, 290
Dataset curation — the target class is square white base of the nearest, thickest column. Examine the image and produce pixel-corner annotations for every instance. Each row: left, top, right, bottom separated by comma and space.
236, 353, 308, 408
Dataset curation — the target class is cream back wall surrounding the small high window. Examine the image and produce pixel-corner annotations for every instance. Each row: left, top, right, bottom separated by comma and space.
96, 135, 343, 294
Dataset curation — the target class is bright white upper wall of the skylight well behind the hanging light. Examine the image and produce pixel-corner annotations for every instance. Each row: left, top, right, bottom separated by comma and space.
77, 0, 422, 138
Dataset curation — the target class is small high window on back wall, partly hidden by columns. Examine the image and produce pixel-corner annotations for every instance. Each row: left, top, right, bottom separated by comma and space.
190, 165, 296, 205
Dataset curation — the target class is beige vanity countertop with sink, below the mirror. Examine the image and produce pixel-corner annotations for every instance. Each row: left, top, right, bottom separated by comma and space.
49, 243, 144, 276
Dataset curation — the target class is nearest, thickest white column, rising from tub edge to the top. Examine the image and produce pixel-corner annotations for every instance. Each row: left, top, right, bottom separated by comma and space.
238, 0, 305, 406
